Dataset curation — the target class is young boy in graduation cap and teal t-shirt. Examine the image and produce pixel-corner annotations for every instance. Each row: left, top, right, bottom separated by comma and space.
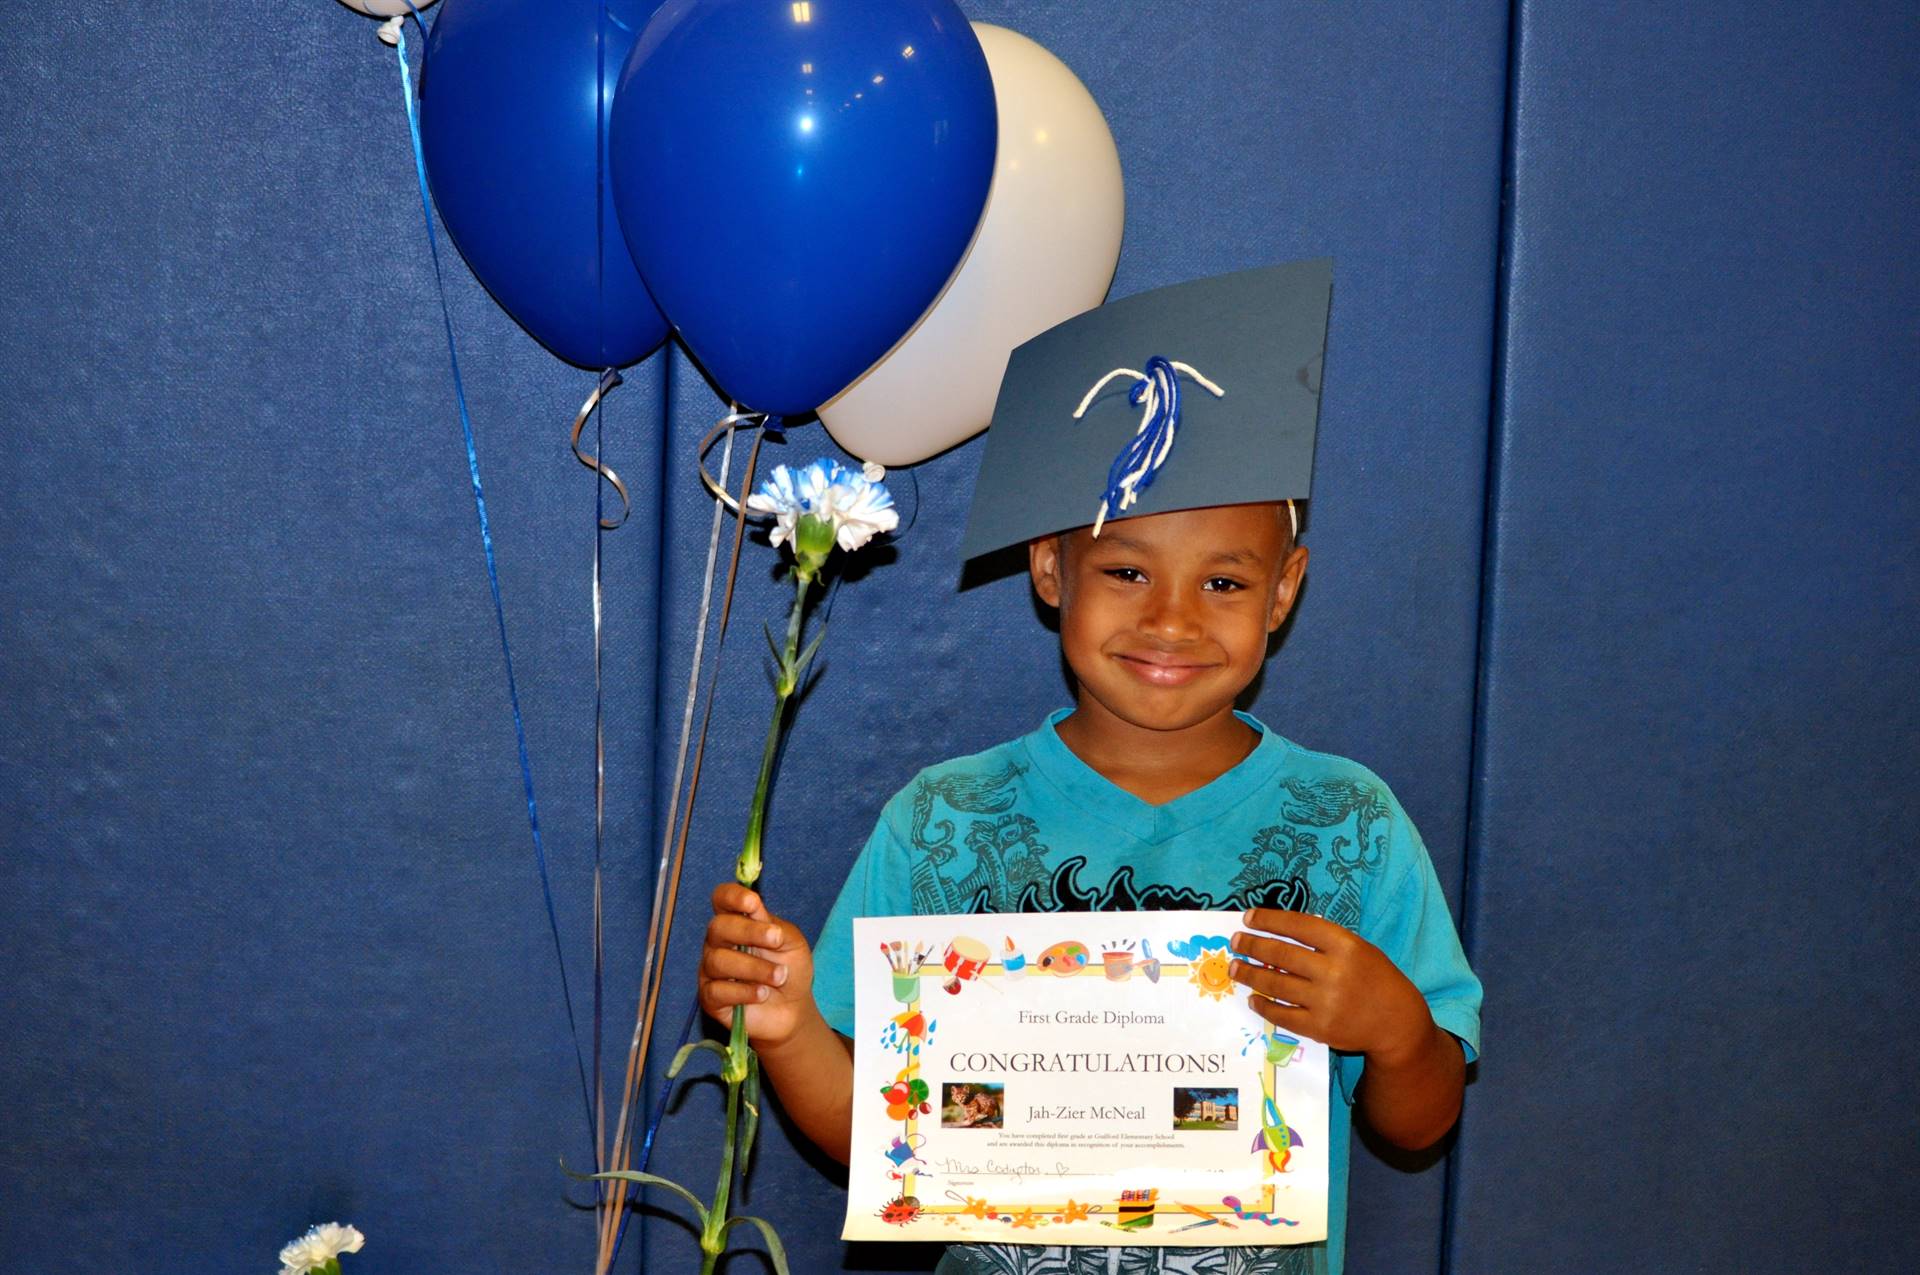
701, 261, 1480, 1275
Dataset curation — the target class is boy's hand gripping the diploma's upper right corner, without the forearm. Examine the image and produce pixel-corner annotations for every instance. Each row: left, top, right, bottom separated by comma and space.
1233, 908, 1434, 1064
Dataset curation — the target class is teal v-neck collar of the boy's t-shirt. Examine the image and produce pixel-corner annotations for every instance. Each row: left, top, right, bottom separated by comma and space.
1025, 709, 1288, 845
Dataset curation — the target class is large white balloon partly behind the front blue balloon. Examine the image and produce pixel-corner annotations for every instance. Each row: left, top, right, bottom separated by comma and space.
820, 23, 1125, 465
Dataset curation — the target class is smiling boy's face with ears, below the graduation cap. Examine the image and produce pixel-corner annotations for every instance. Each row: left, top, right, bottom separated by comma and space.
1027, 503, 1308, 730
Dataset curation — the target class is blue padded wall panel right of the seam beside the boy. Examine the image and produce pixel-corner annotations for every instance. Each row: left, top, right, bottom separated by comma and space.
1452, 0, 1920, 1273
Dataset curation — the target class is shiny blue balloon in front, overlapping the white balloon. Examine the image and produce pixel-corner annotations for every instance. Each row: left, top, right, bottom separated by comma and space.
612, 0, 998, 417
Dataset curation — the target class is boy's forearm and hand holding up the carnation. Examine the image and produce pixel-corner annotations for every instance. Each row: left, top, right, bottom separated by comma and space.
701, 883, 852, 1164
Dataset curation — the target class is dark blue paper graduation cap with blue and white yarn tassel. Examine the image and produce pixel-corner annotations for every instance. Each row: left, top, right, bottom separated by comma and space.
960, 259, 1332, 559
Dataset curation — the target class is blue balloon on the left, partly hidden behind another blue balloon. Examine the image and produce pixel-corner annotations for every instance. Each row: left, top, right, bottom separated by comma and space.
420, 0, 666, 369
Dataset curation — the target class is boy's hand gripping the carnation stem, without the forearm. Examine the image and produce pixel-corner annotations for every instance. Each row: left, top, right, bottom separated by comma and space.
699, 881, 818, 1046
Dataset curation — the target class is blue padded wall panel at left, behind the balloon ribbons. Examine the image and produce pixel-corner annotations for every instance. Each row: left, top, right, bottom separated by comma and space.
0, 0, 662, 1275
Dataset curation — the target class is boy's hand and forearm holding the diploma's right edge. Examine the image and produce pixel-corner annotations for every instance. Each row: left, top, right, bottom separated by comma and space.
1233, 908, 1467, 1150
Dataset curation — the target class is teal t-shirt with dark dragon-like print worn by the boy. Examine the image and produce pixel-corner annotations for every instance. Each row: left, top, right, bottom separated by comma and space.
814, 710, 1480, 1275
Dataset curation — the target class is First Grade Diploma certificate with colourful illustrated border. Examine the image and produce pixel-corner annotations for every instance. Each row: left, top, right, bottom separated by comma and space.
841, 912, 1327, 1246
